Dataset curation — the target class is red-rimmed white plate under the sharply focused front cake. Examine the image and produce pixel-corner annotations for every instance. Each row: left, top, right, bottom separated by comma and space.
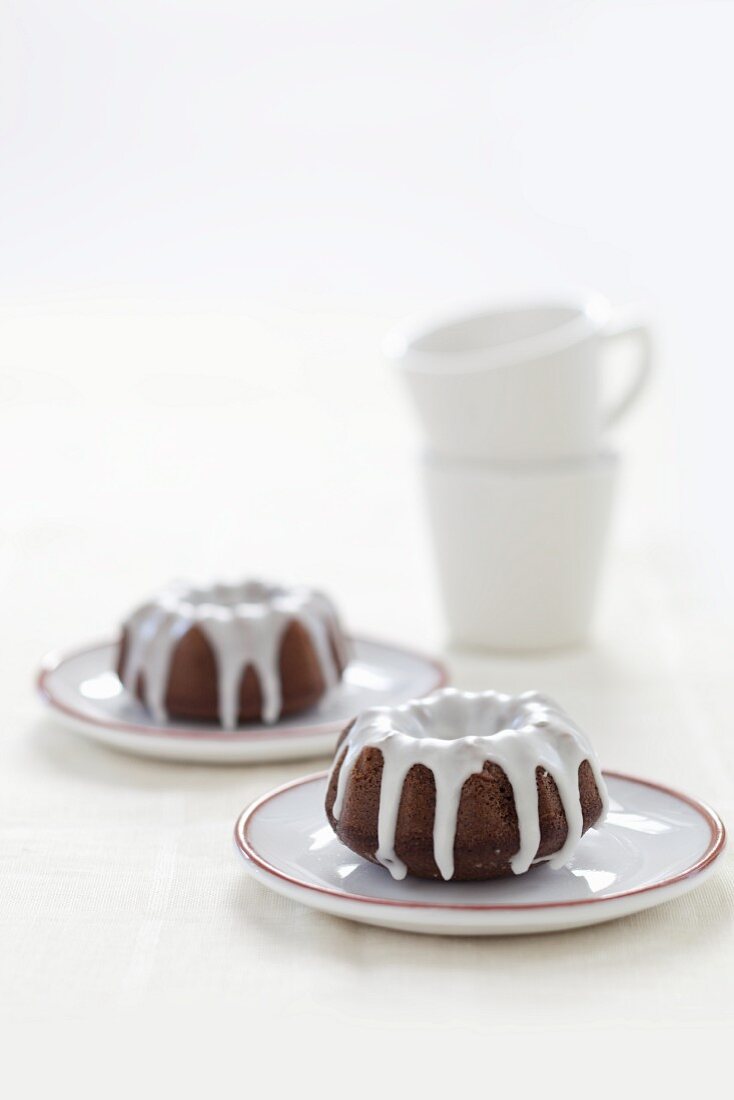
234, 772, 725, 936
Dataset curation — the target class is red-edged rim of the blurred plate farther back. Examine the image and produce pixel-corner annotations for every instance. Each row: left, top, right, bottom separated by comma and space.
34, 634, 449, 745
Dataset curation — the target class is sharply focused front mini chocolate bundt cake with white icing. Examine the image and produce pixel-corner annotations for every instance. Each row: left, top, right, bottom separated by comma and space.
326, 689, 606, 881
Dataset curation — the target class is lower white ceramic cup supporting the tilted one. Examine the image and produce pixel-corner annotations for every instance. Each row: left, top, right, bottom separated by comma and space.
424, 454, 618, 651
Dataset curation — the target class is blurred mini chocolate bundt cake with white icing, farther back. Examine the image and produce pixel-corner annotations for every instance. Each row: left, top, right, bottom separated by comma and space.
118, 581, 348, 729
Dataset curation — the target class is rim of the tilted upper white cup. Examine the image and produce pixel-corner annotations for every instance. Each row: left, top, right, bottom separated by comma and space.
382, 294, 612, 375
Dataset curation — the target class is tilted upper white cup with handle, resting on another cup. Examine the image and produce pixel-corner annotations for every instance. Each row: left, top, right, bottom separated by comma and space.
384, 296, 650, 462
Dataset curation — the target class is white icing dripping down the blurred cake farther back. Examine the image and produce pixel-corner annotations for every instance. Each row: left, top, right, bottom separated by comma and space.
122, 581, 347, 729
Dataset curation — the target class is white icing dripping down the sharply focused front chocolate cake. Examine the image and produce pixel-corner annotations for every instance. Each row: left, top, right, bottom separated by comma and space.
332, 688, 607, 880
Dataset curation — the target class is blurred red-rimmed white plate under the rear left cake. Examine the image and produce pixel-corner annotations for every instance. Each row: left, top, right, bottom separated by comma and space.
37, 638, 446, 763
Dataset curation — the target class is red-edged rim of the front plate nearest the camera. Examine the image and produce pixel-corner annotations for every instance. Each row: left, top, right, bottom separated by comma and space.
234, 769, 726, 913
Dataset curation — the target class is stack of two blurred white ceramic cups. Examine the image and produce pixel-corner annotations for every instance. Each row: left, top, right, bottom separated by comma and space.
385, 297, 650, 651
